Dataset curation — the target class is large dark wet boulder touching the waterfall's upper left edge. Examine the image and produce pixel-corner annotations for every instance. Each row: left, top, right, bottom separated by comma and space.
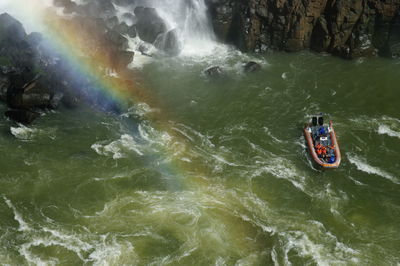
135, 7, 167, 43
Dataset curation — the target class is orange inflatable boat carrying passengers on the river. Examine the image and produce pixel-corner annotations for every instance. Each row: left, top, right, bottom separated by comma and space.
304, 116, 342, 168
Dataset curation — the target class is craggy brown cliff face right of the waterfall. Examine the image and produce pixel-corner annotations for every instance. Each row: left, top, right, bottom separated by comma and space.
207, 0, 400, 58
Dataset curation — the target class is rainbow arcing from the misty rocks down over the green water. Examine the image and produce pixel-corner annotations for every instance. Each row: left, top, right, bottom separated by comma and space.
17, 0, 208, 184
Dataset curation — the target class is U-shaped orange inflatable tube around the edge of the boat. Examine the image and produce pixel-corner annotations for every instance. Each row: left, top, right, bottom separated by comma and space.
304, 121, 342, 169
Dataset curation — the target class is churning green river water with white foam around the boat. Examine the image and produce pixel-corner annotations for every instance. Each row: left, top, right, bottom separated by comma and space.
0, 52, 400, 265
